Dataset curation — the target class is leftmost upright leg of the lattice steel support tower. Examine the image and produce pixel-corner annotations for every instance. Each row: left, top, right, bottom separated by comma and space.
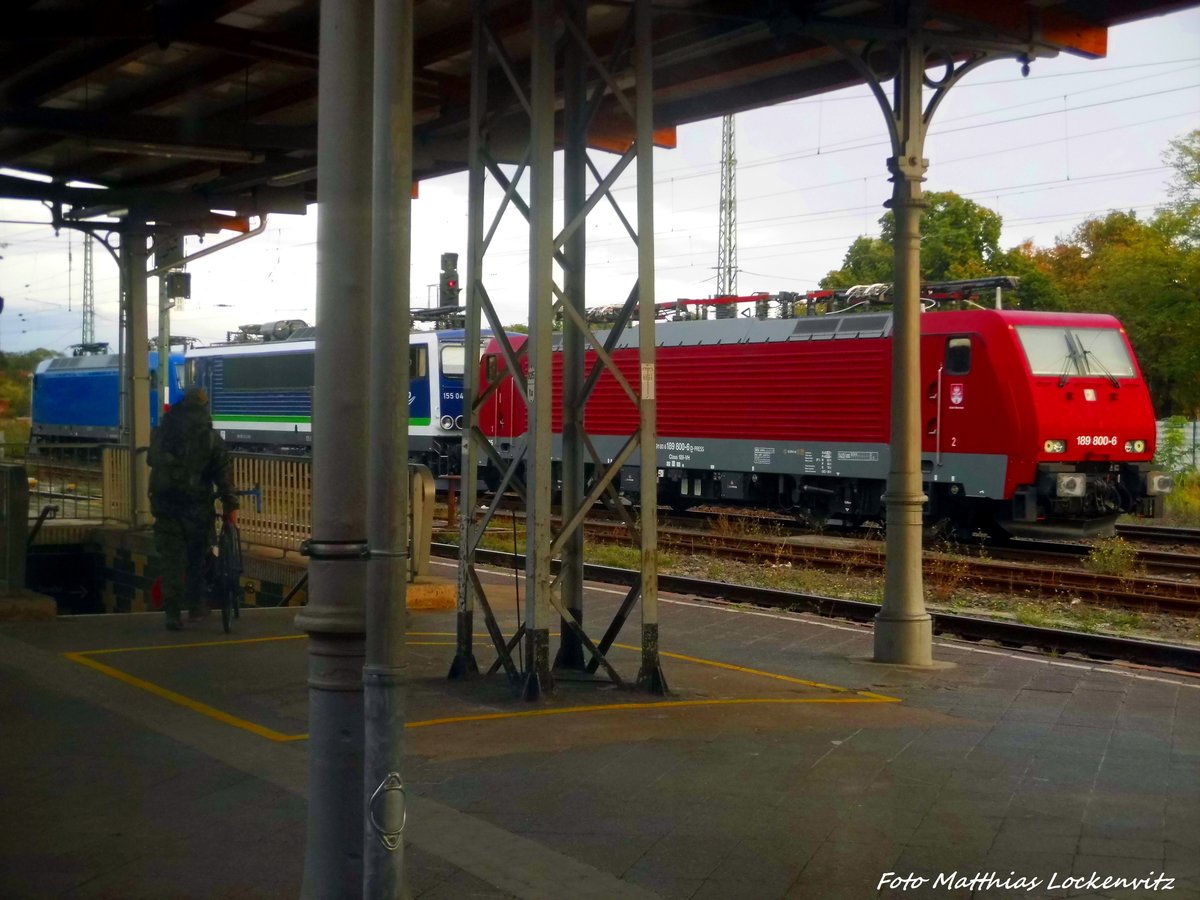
449, 0, 487, 678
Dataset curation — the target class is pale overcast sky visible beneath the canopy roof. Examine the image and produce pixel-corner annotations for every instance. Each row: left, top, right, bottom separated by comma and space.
0, 10, 1200, 352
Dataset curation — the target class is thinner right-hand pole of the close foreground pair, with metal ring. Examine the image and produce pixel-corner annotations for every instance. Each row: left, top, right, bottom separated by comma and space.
362, 0, 413, 898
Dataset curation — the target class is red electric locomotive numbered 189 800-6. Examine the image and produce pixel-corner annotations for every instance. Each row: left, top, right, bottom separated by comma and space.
480, 296, 1171, 536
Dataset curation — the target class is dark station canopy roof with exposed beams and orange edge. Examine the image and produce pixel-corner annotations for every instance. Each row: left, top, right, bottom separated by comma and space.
0, 0, 1194, 236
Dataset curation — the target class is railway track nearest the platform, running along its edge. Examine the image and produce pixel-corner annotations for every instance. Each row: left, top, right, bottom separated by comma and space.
433, 544, 1200, 672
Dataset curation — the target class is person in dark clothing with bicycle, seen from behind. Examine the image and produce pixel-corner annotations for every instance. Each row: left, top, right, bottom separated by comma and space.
148, 388, 238, 631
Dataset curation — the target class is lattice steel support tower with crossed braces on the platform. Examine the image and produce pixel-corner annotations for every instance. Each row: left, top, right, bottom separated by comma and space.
450, 0, 666, 700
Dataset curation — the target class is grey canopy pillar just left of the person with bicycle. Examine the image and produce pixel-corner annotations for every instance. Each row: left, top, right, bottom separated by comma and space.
121, 222, 150, 528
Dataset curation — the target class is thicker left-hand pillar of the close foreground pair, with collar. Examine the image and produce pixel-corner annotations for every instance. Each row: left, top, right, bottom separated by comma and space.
296, 0, 372, 898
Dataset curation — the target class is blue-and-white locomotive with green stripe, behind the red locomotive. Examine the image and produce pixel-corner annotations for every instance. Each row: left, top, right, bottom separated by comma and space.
186, 320, 491, 476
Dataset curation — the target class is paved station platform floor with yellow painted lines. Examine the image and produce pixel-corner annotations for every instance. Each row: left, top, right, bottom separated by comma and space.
0, 562, 1200, 899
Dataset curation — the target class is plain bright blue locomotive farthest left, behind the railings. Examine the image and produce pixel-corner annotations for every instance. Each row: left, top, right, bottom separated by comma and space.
30, 350, 184, 446
